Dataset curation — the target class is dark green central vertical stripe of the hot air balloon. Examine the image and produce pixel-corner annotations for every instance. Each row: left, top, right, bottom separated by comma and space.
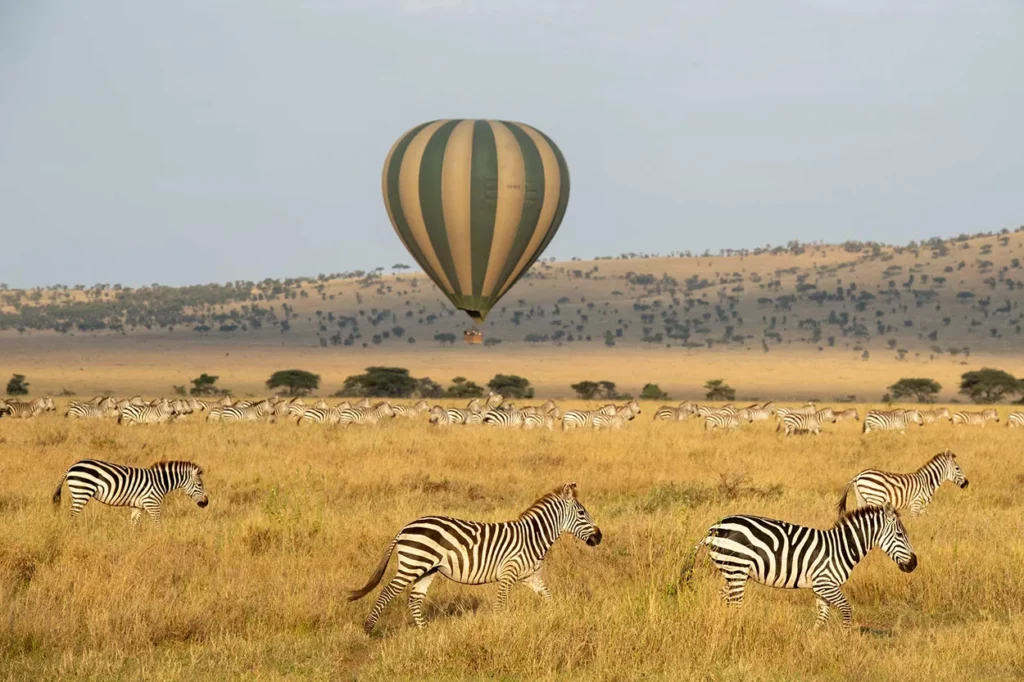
469, 121, 498, 297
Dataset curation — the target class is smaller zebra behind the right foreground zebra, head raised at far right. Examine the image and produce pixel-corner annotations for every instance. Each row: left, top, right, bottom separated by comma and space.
837, 450, 969, 517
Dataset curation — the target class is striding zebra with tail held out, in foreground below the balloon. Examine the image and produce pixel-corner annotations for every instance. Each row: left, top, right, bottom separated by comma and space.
348, 483, 601, 634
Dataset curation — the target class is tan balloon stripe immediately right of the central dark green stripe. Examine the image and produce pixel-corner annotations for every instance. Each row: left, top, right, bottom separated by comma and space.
481, 121, 526, 296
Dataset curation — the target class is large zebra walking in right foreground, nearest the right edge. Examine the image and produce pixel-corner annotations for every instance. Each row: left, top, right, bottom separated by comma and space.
681, 504, 918, 628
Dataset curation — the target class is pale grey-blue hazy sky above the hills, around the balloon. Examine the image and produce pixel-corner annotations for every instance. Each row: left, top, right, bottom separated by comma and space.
0, 0, 1024, 287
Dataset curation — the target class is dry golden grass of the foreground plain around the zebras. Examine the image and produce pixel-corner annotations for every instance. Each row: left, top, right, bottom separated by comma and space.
0, 404, 1024, 680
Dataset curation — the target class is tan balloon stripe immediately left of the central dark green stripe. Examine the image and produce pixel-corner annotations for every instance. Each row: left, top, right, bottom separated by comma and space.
441, 121, 473, 296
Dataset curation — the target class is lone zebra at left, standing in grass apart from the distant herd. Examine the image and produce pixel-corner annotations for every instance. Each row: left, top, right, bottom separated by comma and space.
53, 460, 210, 524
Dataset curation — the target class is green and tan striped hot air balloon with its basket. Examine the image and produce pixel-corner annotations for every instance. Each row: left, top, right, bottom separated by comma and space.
382, 119, 569, 343
